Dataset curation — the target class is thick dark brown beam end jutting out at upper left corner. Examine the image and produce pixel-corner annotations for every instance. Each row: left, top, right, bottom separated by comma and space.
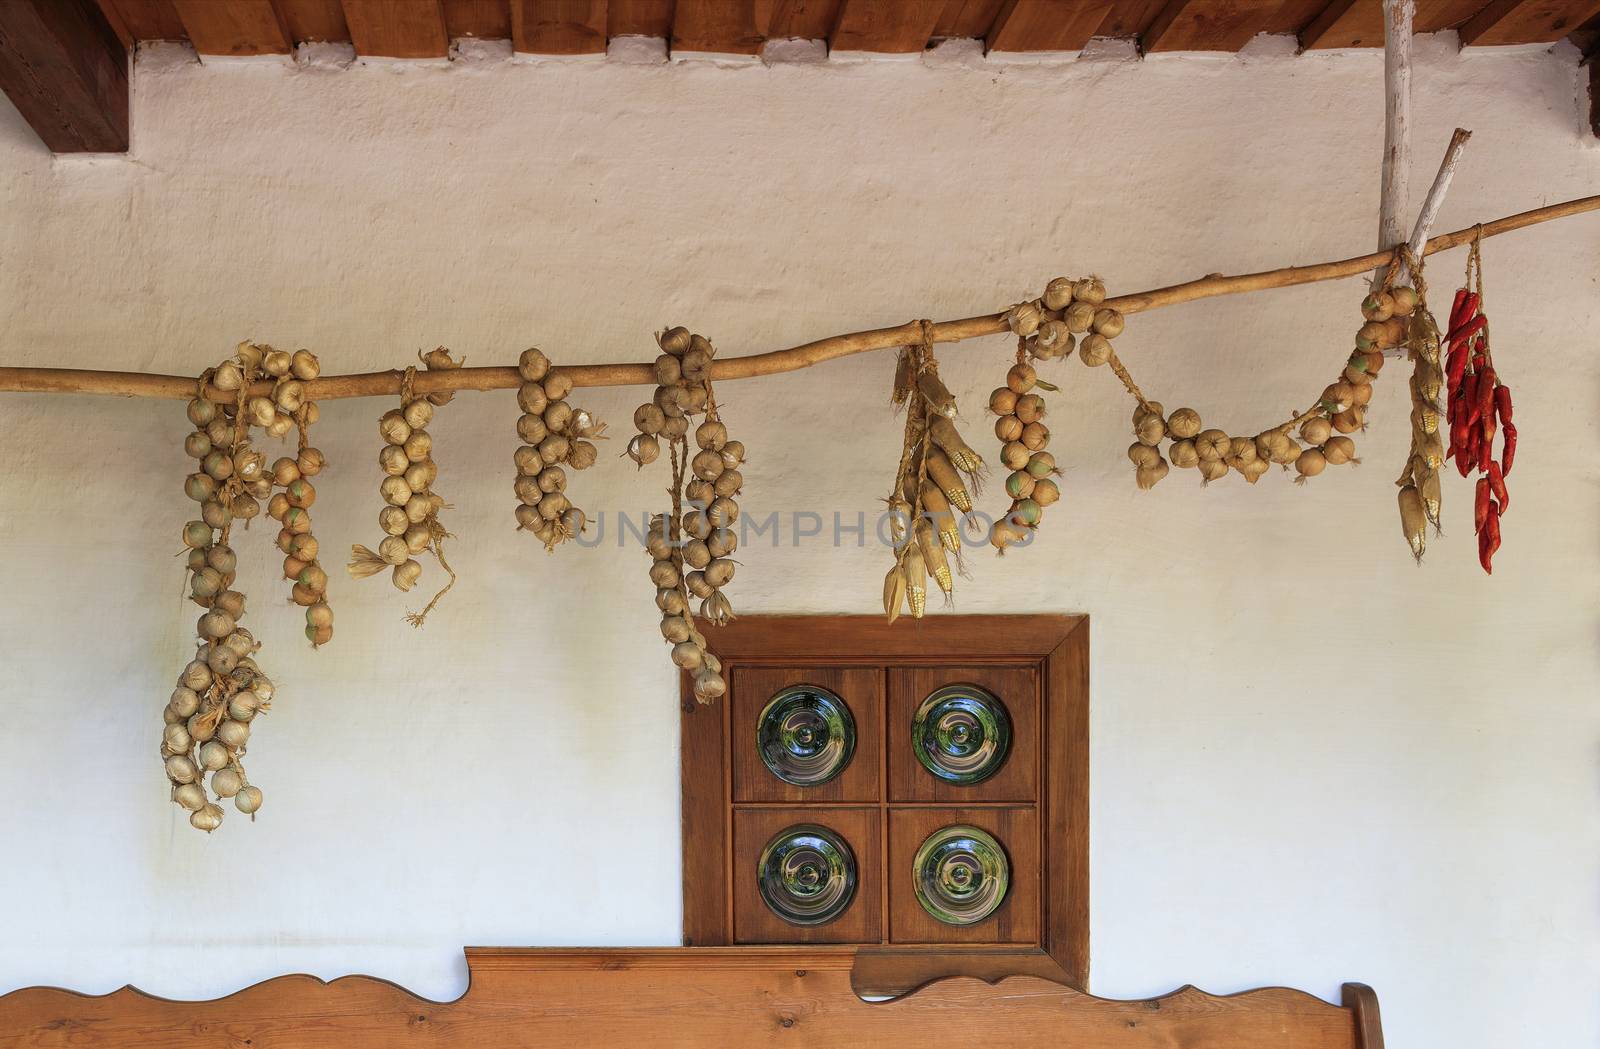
0, 0, 128, 154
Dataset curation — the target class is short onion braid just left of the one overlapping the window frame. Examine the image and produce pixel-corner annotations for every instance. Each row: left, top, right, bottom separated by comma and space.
514, 347, 605, 550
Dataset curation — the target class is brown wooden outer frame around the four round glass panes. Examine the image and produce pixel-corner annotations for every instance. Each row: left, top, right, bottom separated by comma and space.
678, 616, 1090, 993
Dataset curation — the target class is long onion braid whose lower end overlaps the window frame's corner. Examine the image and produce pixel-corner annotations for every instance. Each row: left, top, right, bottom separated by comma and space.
624, 328, 744, 702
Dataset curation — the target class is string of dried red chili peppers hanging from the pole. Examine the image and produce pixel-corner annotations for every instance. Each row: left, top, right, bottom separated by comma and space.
1445, 240, 1517, 574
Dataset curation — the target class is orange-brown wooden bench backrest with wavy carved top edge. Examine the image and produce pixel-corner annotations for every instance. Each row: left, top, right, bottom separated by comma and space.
0, 948, 1381, 1049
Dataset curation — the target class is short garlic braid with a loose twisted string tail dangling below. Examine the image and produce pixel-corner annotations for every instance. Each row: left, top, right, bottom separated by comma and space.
346, 347, 461, 627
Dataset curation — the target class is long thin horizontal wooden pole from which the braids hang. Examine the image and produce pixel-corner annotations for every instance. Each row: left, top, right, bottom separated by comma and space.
0, 195, 1600, 401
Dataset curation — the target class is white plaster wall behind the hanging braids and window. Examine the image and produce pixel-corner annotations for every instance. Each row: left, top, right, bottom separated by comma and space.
0, 36, 1600, 1049
